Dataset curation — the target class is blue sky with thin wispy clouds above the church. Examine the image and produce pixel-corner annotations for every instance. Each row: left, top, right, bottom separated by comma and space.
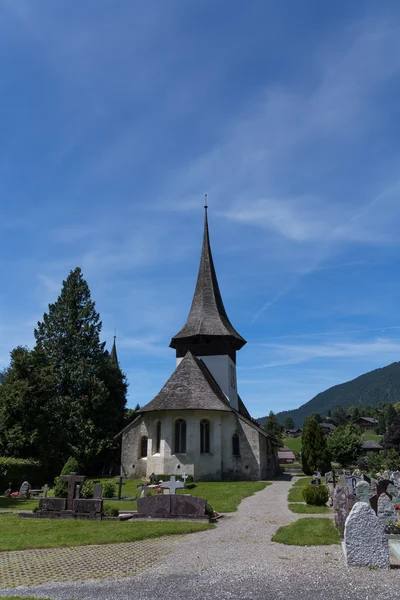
0, 0, 400, 416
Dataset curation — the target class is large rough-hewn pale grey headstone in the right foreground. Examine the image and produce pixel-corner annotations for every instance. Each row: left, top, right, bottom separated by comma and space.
344, 502, 390, 569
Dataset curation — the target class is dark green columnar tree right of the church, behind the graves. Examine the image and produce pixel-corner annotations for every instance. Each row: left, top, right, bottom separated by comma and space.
301, 417, 331, 475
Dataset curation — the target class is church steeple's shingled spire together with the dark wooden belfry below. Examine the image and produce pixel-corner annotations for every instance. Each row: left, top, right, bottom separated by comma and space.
170, 204, 246, 362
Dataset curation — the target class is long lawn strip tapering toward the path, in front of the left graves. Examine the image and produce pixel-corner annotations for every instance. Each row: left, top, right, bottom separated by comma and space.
0, 514, 214, 551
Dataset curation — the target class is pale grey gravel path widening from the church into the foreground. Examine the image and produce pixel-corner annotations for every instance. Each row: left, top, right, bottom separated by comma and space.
0, 480, 400, 600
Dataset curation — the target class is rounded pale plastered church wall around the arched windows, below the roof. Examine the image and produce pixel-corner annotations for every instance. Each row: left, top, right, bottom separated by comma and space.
121, 411, 275, 481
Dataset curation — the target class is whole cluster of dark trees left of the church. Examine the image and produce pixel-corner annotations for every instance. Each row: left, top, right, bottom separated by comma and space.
0, 268, 127, 474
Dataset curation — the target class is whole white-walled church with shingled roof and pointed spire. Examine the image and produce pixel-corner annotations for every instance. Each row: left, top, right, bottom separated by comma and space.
119, 206, 279, 481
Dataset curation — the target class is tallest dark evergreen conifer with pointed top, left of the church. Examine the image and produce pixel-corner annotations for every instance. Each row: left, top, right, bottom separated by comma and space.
34, 268, 126, 466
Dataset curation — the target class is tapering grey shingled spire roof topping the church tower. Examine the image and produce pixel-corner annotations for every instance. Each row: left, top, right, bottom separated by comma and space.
170, 204, 246, 350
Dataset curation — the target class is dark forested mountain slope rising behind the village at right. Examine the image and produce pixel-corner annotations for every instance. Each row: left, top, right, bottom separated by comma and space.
259, 362, 400, 426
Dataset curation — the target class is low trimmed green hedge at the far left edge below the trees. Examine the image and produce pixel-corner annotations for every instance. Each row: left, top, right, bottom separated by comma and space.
0, 456, 44, 494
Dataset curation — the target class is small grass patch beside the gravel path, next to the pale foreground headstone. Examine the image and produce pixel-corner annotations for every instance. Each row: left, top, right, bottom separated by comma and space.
272, 518, 340, 546
